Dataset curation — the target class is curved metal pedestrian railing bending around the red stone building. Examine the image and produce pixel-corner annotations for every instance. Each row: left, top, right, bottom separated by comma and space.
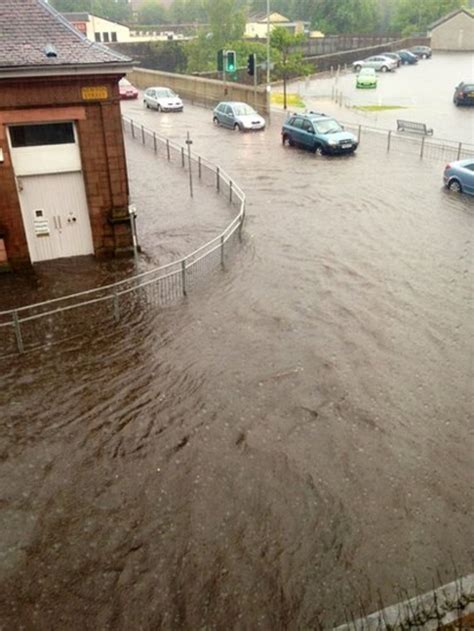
0, 117, 245, 357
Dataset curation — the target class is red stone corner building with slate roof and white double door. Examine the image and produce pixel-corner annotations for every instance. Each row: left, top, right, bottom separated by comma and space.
0, 0, 132, 268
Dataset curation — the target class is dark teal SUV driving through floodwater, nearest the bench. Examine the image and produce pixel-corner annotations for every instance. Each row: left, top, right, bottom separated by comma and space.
281, 112, 358, 155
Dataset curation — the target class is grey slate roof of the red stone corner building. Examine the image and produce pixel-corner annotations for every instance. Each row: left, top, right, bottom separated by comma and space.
0, 0, 132, 70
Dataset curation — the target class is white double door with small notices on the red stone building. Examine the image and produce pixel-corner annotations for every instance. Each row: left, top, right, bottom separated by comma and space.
17, 171, 94, 263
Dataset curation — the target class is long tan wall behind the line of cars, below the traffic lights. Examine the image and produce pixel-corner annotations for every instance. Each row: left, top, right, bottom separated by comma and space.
127, 68, 269, 114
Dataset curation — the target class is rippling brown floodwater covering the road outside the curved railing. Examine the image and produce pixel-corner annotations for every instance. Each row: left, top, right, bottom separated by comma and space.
0, 68, 474, 631
